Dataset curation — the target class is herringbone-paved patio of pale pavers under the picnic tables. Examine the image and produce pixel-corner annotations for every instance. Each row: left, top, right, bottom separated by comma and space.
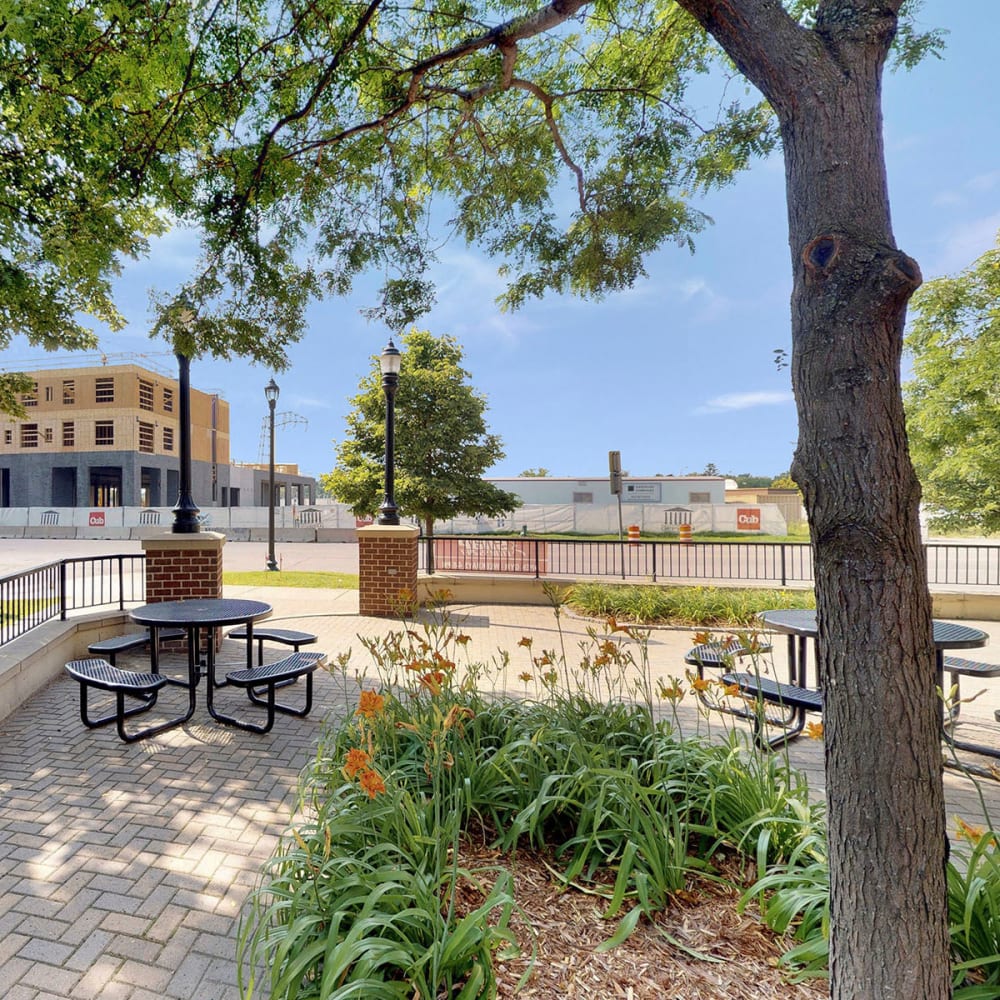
0, 588, 1000, 1000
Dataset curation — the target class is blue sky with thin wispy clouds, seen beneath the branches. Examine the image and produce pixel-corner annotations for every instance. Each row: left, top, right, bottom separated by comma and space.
0, 0, 1000, 477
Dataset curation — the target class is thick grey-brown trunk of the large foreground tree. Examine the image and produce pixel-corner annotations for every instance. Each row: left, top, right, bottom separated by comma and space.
680, 0, 951, 1000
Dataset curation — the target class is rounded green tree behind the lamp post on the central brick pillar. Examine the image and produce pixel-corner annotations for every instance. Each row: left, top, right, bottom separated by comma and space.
320, 330, 521, 536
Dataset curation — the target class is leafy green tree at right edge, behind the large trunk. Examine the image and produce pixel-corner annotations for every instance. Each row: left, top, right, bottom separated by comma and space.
905, 234, 1000, 533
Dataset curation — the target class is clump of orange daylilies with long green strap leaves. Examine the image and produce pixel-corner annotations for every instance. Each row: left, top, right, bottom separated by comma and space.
240, 588, 1000, 1000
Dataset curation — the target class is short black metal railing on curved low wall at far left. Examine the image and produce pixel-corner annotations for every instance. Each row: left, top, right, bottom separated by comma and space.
0, 553, 146, 646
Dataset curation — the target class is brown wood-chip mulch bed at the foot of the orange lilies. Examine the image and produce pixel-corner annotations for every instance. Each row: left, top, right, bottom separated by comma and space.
457, 842, 827, 1000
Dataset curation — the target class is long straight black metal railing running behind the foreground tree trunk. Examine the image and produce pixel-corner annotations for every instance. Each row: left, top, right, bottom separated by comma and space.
420, 535, 1000, 587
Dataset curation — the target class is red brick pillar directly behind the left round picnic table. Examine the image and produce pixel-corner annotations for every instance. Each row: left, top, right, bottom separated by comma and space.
142, 531, 226, 649
